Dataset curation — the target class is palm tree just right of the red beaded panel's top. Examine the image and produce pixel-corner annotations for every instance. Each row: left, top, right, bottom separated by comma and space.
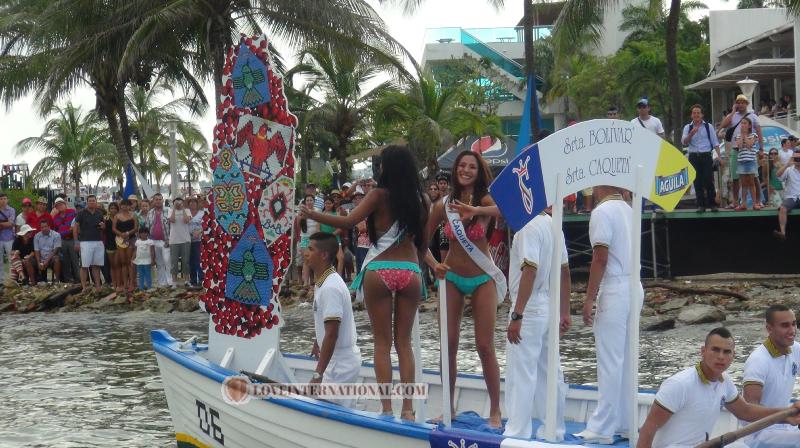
297, 46, 391, 178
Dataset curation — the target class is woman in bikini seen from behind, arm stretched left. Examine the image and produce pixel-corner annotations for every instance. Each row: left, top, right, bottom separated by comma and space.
301, 146, 430, 420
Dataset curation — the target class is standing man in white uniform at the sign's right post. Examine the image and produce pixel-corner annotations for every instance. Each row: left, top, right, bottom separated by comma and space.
577, 185, 644, 444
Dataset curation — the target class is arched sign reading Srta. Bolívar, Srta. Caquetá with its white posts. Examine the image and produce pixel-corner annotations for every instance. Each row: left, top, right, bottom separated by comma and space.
488, 120, 695, 446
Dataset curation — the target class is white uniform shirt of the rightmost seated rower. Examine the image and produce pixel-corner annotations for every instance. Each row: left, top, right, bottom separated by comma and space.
742, 339, 800, 427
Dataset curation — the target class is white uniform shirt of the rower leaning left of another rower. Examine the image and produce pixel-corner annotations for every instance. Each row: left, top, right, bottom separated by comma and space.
652, 364, 739, 448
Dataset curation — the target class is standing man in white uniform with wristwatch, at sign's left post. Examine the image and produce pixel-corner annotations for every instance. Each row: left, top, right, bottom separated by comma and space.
503, 213, 571, 441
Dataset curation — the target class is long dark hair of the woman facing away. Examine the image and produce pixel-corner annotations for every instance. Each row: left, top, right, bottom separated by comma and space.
367, 145, 428, 249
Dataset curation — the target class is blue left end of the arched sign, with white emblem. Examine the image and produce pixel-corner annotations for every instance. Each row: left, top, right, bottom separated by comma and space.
489, 144, 548, 231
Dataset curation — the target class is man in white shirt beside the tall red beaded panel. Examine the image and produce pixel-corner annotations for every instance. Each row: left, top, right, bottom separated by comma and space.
303, 232, 361, 407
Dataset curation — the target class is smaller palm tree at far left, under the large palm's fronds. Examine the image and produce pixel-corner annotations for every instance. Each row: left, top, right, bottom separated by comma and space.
16, 103, 116, 198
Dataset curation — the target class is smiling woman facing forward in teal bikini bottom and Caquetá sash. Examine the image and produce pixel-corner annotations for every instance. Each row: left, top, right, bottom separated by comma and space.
425, 151, 500, 428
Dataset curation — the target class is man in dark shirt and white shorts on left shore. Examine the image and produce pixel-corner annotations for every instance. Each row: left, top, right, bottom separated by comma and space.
72, 195, 106, 289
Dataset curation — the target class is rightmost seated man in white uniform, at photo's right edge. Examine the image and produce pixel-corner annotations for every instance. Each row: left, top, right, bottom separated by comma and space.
742, 305, 800, 448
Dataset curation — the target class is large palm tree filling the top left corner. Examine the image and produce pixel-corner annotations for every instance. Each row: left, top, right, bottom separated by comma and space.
0, 0, 205, 178
